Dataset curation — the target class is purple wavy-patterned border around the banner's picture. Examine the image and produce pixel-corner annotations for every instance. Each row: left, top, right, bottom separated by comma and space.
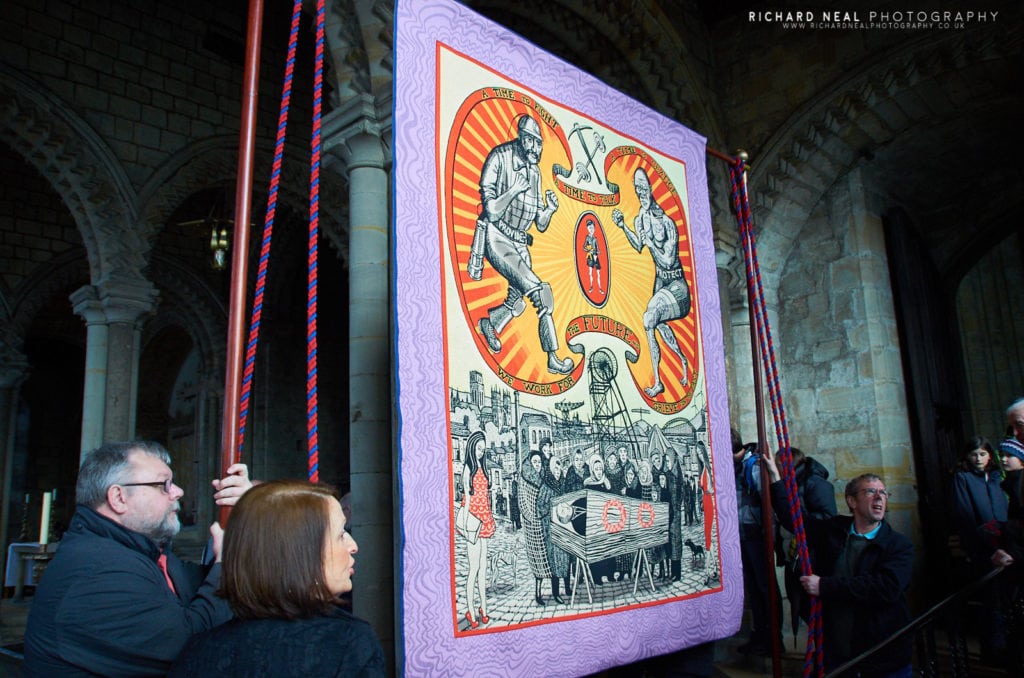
392, 0, 742, 676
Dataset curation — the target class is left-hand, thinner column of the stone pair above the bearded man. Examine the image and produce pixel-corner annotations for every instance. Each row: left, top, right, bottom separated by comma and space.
71, 285, 108, 456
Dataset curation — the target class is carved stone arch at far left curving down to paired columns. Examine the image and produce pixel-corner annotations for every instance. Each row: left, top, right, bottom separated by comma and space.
0, 63, 144, 282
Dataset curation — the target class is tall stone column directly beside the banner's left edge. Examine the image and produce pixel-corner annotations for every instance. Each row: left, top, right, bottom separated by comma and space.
324, 95, 396, 658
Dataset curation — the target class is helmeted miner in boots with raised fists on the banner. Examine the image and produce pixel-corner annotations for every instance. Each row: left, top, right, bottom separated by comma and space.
470, 115, 572, 374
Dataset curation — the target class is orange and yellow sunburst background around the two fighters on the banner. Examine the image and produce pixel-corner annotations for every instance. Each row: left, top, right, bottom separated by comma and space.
444, 87, 700, 413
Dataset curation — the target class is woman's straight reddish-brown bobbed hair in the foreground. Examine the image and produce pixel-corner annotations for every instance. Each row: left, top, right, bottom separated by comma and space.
220, 480, 337, 620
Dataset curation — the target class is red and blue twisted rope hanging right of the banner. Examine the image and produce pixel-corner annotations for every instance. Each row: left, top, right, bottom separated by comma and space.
729, 158, 824, 676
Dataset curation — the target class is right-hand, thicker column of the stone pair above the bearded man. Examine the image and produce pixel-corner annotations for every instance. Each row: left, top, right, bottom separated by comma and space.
96, 280, 157, 440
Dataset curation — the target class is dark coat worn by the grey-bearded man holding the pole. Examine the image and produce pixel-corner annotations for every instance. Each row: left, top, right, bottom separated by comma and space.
25, 506, 231, 676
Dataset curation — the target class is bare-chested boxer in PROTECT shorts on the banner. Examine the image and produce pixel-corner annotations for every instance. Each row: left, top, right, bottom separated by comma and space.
611, 168, 690, 397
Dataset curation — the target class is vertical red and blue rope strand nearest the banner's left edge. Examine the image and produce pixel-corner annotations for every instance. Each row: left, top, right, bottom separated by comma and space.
306, 0, 326, 482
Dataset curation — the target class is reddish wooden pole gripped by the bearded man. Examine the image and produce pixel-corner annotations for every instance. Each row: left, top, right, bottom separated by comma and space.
218, 0, 263, 525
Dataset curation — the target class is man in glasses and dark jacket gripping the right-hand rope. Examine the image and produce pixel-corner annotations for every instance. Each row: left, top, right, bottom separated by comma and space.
765, 452, 913, 678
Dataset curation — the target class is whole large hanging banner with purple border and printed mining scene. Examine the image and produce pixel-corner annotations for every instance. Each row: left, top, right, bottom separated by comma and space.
393, 0, 742, 675
